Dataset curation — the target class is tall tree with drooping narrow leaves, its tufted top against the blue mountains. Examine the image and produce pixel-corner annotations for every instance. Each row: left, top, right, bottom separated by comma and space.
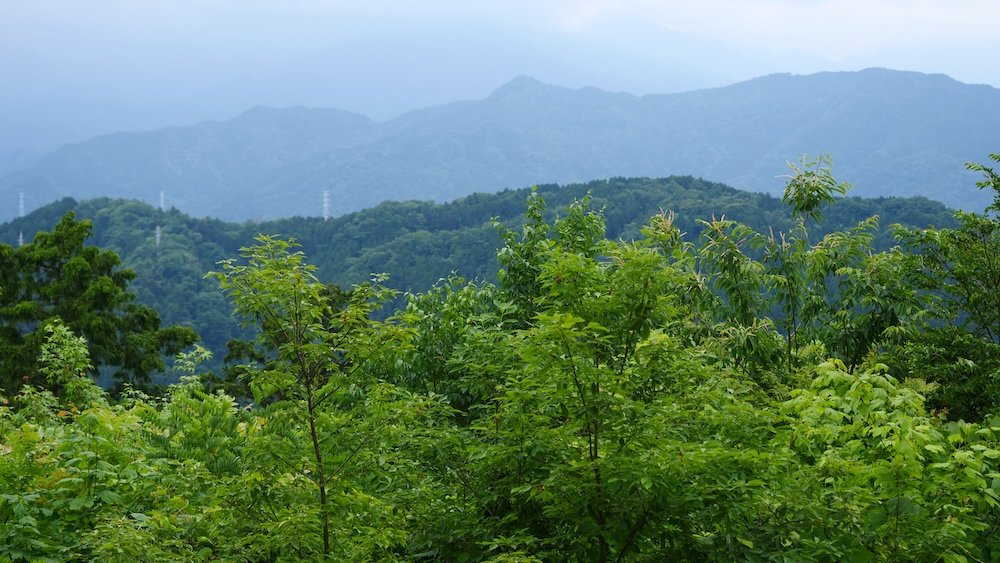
694, 156, 930, 387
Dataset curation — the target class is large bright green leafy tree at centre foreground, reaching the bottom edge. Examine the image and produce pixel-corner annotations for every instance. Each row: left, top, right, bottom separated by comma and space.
461, 202, 760, 561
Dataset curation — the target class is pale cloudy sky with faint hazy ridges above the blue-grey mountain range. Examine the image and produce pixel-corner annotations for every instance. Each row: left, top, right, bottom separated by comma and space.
0, 0, 1000, 159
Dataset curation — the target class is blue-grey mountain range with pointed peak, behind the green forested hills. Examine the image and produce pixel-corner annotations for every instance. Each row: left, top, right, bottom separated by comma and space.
0, 69, 1000, 220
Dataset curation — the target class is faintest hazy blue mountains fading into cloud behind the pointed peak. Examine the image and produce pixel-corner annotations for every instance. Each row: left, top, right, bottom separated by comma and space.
0, 18, 784, 165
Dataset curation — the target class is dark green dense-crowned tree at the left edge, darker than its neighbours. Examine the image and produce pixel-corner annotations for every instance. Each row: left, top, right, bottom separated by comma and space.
0, 212, 197, 393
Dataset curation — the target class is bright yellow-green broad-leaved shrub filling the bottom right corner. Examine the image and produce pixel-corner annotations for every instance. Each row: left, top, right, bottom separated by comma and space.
775, 360, 1000, 561
